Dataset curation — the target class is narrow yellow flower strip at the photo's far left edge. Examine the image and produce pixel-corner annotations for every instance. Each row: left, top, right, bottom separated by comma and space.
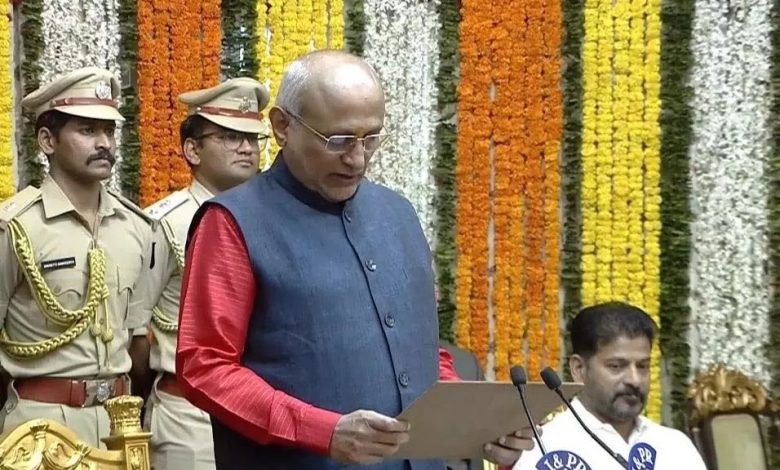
0, 2, 14, 201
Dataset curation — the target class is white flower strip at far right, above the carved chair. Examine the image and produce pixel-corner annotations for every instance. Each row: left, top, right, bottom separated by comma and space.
690, 0, 772, 385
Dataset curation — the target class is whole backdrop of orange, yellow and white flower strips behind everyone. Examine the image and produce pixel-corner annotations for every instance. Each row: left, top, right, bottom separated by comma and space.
0, 0, 780, 452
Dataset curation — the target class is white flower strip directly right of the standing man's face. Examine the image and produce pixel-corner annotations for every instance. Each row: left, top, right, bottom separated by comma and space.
364, 0, 439, 246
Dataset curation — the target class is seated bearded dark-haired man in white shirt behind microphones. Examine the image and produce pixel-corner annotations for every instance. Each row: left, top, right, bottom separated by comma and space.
514, 302, 706, 470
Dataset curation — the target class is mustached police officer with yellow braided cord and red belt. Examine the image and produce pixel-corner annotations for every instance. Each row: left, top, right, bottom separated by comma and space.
0, 67, 152, 446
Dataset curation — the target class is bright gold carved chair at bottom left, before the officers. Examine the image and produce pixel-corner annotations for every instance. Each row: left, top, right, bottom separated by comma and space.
0, 395, 151, 470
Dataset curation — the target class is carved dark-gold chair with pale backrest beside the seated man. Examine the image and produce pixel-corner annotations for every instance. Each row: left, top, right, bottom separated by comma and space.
688, 365, 780, 470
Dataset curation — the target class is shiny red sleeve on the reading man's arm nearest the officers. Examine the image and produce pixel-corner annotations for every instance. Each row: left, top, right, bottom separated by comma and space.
176, 206, 342, 454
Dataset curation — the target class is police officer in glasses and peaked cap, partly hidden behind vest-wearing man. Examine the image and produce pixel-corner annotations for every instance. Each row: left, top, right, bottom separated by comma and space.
135, 78, 269, 470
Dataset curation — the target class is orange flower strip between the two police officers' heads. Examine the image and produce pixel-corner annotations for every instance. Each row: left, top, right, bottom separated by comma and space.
138, 0, 222, 206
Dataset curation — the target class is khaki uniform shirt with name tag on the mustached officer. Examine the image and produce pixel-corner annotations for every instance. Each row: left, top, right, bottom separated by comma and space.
0, 177, 152, 378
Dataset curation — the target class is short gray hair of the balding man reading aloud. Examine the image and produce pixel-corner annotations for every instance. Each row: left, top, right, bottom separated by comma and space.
275, 50, 382, 116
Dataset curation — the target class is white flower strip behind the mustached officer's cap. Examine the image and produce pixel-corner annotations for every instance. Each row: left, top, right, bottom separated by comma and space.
39, 0, 122, 190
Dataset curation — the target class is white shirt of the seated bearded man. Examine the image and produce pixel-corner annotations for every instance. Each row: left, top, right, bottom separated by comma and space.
514, 399, 706, 470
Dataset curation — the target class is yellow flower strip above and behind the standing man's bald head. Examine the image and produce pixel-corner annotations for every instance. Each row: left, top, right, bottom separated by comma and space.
255, 0, 344, 168
